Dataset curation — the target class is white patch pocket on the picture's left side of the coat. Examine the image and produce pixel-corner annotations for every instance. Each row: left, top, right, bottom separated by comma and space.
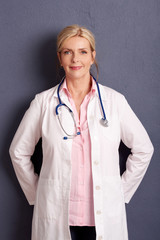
35, 179, 63, 220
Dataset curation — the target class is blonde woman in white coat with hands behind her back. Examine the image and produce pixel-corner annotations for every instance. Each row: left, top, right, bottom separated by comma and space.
10, 25, 153, 240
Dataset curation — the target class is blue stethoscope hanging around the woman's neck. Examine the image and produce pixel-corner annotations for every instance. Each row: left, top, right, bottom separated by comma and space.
55, 75, 108, 140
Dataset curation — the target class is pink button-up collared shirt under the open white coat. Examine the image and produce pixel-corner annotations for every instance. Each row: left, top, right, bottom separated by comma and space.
62, 79, 96, 226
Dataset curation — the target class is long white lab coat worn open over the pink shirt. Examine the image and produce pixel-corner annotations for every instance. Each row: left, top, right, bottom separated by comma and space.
10, 85, 153, 240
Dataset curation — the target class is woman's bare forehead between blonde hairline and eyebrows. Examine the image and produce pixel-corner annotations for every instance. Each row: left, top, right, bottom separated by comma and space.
62, 36, 90, 49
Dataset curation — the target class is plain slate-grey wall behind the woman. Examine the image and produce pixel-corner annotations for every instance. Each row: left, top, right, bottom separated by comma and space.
0, 0, 160, 240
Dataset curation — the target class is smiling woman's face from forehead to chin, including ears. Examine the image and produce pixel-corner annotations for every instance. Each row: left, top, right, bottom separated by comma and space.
58, 36, 96, 79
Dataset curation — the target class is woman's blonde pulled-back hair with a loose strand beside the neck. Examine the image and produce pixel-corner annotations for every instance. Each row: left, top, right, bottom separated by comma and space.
57, 24, 99, 78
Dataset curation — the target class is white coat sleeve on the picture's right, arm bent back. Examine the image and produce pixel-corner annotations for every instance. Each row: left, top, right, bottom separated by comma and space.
120, 98, 153, 203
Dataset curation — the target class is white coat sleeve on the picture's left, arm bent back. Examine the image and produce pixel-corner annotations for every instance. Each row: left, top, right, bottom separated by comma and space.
9, 96, 41, 205
